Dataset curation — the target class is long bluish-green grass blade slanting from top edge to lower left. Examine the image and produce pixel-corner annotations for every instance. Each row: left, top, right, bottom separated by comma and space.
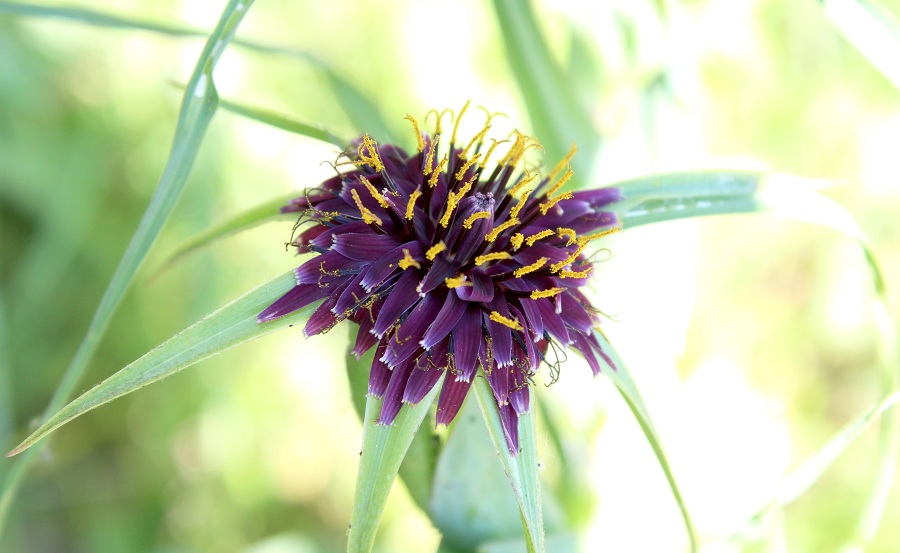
0, 0, 252, 531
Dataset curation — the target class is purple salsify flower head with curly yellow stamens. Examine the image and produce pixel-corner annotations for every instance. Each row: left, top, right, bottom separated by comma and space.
258, 104, 621, 454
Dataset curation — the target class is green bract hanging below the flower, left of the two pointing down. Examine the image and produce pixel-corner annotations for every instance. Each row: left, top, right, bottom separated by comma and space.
347, 384, 443, 553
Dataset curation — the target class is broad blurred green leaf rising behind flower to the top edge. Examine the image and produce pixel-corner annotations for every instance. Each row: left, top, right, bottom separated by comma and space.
493, 0, 600, 180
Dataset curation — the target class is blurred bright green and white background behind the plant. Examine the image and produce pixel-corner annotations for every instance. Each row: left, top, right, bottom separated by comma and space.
0, 0, 900, 553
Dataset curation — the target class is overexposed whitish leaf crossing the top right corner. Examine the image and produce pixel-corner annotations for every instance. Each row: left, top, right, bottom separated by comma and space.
822, 0, 900, 89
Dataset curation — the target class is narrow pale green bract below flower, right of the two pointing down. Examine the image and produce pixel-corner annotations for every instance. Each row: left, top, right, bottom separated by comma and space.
472, 378, 546, 553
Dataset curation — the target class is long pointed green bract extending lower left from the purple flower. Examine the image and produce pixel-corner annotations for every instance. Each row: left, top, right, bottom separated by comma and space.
7, 271, 315, 456
